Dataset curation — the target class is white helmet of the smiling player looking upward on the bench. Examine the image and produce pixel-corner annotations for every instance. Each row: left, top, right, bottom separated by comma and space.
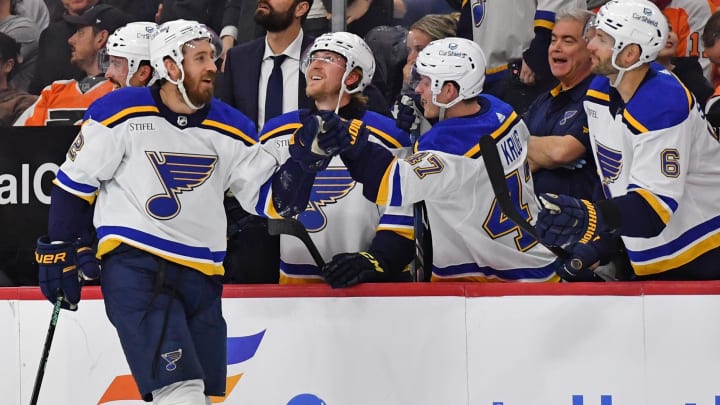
302, 32, 375, 94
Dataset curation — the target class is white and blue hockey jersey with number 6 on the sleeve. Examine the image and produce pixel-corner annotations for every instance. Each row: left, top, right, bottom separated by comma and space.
584, 69, 720, 275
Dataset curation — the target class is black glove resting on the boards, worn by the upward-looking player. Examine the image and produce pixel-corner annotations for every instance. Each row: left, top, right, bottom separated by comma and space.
322, 252, 385, 288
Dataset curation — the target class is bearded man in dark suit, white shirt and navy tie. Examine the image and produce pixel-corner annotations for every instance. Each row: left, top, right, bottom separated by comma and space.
218, 0, 313, 283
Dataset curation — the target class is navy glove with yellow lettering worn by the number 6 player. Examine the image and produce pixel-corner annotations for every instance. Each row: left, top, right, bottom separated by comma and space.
535, 193, 611, 246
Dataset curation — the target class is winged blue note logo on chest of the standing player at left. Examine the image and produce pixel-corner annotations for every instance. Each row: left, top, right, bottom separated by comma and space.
145, 152, 217, 219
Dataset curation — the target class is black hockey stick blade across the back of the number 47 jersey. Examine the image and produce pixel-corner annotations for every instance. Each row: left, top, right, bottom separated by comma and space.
480, 135, 570, 259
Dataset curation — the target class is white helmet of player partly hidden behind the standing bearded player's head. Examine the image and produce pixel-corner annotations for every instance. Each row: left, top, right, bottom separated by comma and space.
105, 21, 157, 86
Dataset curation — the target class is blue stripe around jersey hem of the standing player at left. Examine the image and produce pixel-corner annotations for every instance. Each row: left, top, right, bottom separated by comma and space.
97, 226, 225, 265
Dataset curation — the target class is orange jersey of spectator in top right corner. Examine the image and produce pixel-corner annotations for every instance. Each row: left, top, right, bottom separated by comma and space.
663, 0, 718, 79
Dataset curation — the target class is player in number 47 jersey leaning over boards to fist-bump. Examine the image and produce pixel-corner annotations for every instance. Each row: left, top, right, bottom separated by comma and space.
318, 38, 558, 281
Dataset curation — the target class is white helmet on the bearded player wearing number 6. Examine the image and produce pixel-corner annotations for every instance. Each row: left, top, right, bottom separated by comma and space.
594, 0, 669, 71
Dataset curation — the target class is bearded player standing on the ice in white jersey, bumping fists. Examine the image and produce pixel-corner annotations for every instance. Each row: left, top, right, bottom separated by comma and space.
36, 20, 332, 405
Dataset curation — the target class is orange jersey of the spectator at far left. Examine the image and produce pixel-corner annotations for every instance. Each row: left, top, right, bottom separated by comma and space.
14, 80, 113, 126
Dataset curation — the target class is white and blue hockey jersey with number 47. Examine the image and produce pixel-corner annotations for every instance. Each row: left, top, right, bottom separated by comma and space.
359, 95, 558, 281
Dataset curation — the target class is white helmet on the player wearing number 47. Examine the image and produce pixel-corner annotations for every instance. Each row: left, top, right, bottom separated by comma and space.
415, 37, 487, 108
